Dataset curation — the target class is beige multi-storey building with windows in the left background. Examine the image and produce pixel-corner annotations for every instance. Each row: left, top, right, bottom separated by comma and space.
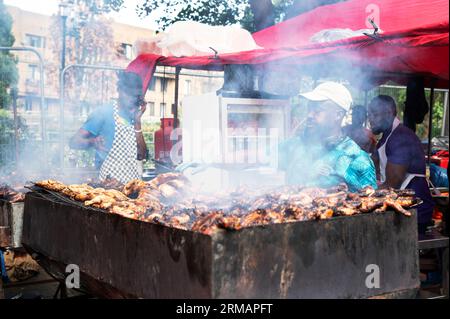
7, 6, 223, 121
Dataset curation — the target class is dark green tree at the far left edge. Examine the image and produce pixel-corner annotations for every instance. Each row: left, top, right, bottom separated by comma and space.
0, 0, 18, 108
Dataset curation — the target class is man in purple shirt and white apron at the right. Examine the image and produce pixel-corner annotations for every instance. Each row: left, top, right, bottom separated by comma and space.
368, 95, 434, 233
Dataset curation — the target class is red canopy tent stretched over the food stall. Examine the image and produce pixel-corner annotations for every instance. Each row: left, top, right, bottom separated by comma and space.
127, 0, 449, 88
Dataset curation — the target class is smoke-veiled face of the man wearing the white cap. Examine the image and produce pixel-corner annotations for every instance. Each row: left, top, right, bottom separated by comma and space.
305, 101, 344, 139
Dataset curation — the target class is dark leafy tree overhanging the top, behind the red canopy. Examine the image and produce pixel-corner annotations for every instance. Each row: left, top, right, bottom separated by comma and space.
137, 0, 343, 32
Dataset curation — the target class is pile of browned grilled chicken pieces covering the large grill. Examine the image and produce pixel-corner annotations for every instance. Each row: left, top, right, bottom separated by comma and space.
36, 173, 418, 234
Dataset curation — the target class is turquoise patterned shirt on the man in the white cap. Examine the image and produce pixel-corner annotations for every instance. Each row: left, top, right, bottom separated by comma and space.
278, 137, 377, 191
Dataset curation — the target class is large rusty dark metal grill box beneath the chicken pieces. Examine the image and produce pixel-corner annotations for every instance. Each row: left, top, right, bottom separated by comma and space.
23, 192, 419, 298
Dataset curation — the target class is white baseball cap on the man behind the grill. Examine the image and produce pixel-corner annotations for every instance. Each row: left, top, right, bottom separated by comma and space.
300, 82, 353, 112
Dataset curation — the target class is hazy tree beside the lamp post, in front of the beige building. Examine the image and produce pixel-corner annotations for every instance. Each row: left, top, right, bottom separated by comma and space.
50, 0, 123, 110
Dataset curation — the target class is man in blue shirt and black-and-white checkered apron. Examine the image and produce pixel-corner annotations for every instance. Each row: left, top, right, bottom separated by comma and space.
70, 72, 147, 183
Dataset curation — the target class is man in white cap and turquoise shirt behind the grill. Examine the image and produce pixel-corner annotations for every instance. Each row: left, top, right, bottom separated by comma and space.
279, 82, 377, 191
